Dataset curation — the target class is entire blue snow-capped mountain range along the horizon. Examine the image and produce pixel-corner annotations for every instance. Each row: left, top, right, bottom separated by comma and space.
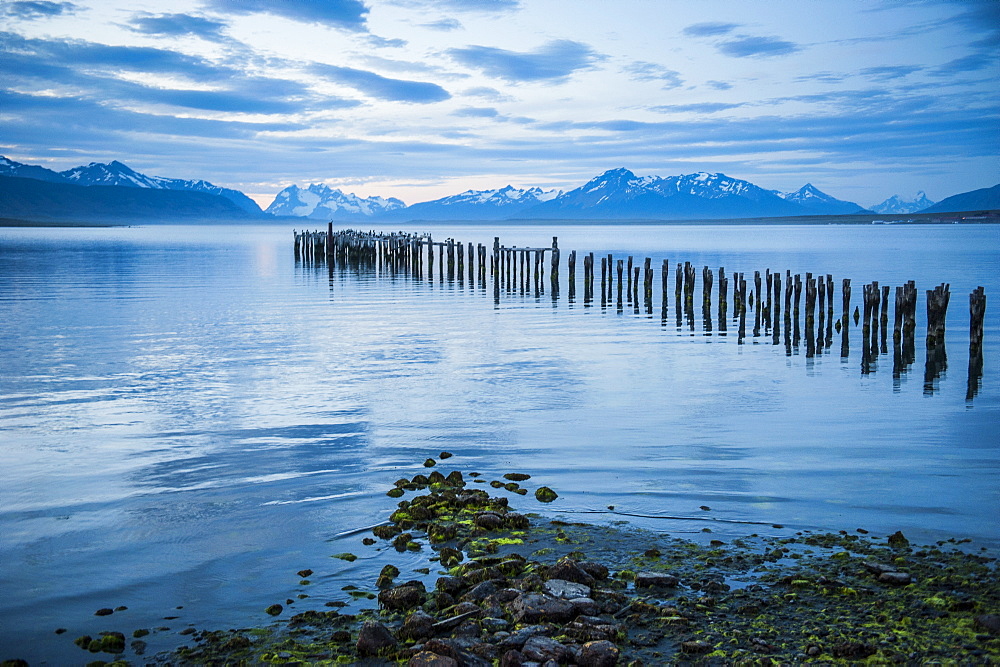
0, 156, 1000, 222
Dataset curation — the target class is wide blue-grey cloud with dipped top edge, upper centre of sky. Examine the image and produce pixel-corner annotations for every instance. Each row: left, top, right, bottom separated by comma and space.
448, 39, 603, 83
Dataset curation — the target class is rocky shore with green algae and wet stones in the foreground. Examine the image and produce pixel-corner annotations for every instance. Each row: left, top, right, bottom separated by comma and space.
27, 460, 1000, 667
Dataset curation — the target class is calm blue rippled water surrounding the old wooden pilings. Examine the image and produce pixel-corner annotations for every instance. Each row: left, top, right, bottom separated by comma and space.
0, 224, 1000, 664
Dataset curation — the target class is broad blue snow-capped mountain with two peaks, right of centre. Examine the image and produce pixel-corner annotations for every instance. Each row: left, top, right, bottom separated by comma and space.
525, 168, 811, 219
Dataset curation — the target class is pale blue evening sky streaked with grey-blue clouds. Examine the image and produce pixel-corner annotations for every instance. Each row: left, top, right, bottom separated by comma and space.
0, 0, 1000, 206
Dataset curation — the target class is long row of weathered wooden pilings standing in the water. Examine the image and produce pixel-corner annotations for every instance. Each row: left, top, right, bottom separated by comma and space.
295, 230, 986, 399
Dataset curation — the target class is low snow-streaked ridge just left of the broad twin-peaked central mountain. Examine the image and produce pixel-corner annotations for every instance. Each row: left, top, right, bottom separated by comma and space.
393, 185, 562, 220
